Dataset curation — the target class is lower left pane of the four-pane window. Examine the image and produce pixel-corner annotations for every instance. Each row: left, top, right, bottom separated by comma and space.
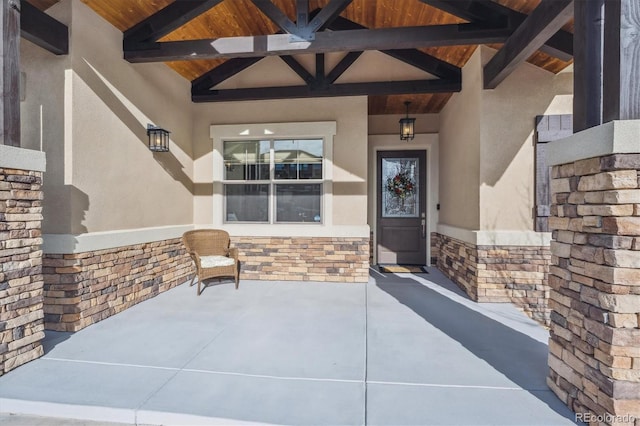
224, 184, 269, 222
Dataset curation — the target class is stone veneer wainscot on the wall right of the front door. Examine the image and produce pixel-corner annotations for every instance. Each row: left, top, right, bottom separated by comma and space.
436, 234, 551, 324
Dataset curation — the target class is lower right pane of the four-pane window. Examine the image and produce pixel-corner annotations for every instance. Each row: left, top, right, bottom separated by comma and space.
276, 183, 322, 223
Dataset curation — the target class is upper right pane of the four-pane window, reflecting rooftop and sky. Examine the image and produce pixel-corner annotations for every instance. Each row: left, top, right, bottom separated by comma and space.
274, 139, 322, 179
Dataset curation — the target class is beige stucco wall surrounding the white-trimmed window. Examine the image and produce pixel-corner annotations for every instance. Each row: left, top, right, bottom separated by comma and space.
193, 96, 367, 234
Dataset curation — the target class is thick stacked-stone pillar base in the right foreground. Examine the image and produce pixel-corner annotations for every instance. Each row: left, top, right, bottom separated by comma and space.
547, 154, 640, 426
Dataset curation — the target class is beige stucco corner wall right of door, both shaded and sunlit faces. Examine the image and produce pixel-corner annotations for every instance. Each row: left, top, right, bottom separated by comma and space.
440, 46, 573, 235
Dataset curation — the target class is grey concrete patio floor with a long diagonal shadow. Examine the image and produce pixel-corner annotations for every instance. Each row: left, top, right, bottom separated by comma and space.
0, 268, 574, 425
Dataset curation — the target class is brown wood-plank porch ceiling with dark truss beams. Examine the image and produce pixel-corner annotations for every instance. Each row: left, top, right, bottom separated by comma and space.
27, 0, 573, 115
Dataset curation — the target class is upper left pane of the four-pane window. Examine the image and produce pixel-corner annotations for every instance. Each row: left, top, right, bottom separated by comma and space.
224, 141, 269, 180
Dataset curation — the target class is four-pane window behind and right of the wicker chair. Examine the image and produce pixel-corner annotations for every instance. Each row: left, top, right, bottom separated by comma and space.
223, 138, 325, 224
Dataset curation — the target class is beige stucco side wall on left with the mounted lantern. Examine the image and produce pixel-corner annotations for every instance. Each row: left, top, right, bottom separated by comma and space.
22, 0, 193, 234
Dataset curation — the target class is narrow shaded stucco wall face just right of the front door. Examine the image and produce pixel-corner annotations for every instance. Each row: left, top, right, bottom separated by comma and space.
440, 50, 482, 229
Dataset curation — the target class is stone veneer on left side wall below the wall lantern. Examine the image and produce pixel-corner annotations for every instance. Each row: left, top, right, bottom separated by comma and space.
43, 238, 195, 331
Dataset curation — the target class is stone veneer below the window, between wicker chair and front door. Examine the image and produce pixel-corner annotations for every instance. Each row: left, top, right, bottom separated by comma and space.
231, 237, 369, 285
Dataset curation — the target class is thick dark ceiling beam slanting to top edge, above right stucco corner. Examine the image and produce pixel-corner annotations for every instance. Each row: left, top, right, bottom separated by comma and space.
484, 0, 573, 89
